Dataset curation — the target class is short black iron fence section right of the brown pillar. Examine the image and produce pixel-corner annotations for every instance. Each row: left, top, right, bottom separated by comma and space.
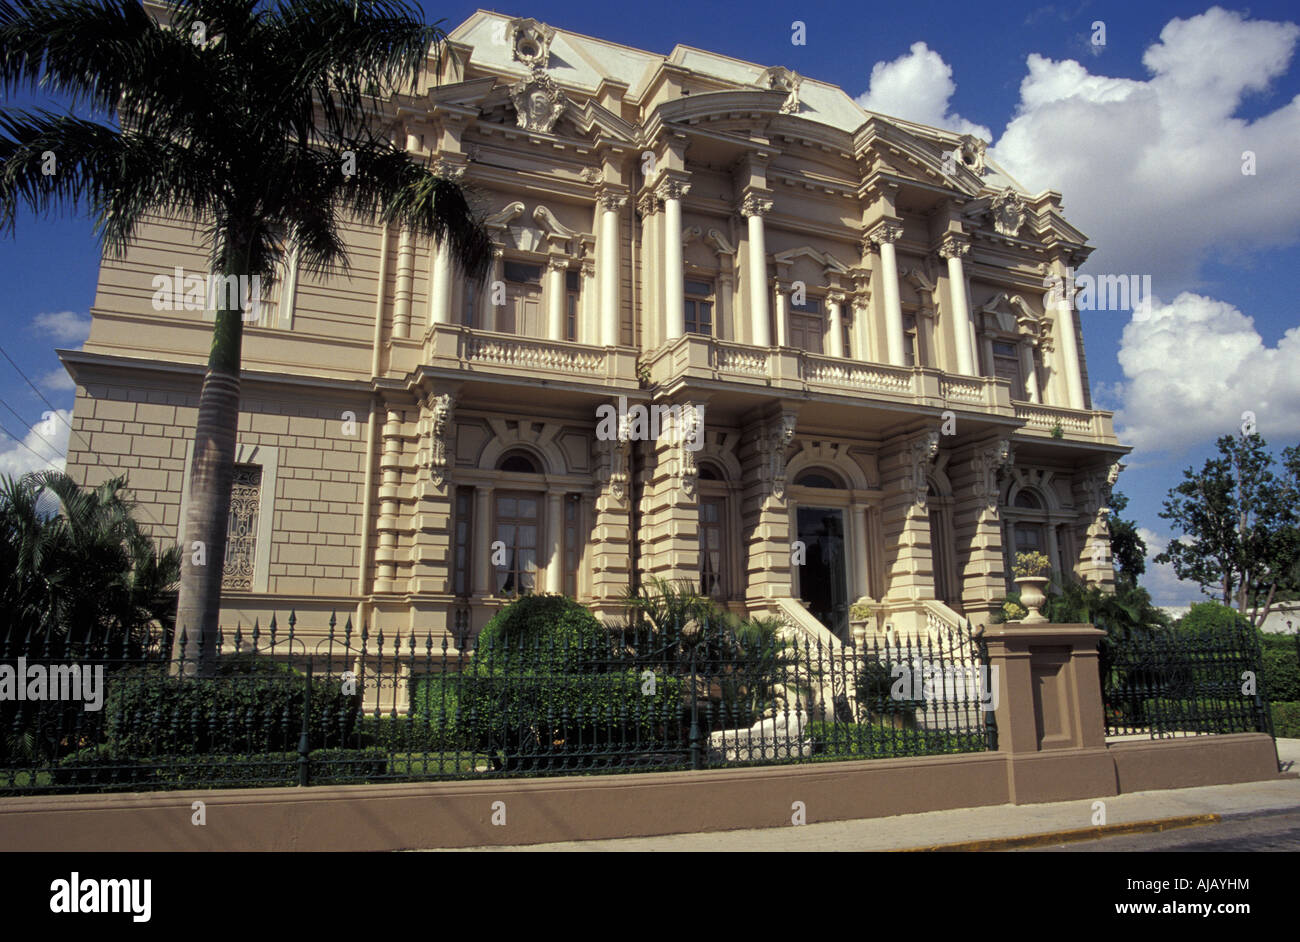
1100, 625, 1273, 738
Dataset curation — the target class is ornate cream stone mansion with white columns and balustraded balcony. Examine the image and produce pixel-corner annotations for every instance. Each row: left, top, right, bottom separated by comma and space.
62, 12, 1127, 647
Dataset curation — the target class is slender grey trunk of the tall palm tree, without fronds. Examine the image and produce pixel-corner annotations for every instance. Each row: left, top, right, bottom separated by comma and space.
172, 239, 250, 676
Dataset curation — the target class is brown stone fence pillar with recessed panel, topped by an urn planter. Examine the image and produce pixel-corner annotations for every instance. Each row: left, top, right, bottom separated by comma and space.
984, 622, 1118, 803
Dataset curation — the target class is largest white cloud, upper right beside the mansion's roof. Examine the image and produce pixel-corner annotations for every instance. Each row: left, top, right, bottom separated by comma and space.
991, 6, 1300, 287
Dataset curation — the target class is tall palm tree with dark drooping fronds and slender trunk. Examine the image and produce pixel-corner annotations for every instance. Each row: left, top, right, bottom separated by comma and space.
0, 0, 491, 673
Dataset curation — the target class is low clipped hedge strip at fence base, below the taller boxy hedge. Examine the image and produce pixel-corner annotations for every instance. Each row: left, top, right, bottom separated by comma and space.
53, 746, 389, 791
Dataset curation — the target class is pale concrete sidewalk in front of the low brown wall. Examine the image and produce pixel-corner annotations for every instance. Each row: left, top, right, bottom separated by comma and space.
418, 739, 1300, 851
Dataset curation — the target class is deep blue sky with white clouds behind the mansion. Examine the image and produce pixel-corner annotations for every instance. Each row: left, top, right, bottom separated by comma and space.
0, 0, 1300, 604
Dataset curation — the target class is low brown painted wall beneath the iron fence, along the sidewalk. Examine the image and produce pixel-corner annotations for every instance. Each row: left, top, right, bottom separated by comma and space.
0, 733, 1278, 851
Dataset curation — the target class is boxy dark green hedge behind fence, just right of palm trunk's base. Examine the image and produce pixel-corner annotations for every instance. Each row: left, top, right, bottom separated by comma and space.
104, 664, 361, 756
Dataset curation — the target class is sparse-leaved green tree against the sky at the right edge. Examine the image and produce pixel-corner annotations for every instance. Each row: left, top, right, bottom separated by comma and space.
1156, 434, 1300, 626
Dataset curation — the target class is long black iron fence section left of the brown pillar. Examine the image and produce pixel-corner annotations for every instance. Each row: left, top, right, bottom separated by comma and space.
0, 616, 997, 795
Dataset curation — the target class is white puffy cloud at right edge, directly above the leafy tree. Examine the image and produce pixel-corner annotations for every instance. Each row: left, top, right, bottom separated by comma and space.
1115, 291, 1300, 451
